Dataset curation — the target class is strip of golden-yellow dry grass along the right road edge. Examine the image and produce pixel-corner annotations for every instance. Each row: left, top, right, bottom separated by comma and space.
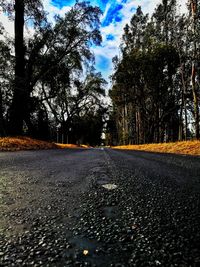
113, 141, 200, 156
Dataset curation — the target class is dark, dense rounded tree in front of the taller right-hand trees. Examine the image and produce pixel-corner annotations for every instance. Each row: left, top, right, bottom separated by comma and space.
110, 45, 179, 143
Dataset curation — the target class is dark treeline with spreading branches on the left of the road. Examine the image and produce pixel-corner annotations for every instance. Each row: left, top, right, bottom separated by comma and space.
0, 0, 105, 145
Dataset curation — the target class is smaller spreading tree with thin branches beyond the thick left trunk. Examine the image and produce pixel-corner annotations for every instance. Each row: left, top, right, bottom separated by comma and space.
40, 69, 105, 142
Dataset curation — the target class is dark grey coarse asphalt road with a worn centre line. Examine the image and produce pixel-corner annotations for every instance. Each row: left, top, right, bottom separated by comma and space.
0, 149, 200, 267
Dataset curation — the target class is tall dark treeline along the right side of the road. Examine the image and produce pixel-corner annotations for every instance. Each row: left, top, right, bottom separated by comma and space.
107, 0, 200, 147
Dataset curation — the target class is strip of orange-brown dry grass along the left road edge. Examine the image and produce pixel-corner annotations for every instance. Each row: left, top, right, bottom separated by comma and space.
0, 136, 87, 151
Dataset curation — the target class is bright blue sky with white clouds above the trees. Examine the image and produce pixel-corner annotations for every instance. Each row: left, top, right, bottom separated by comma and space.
0, 0, 186, 84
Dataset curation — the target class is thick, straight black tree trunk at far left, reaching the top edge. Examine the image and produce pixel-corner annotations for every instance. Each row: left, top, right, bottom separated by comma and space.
10, 0, 27, 135
